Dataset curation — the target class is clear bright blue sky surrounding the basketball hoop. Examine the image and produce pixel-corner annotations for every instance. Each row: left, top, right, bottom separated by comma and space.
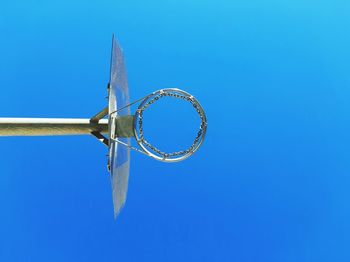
0, 0, 350, 262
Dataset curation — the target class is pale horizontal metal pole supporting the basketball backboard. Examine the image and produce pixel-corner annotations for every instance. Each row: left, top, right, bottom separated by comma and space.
0, 118, 108, 136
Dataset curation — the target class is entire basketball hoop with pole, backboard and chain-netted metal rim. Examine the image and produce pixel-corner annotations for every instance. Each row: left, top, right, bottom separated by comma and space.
0, 36, 207, 217
